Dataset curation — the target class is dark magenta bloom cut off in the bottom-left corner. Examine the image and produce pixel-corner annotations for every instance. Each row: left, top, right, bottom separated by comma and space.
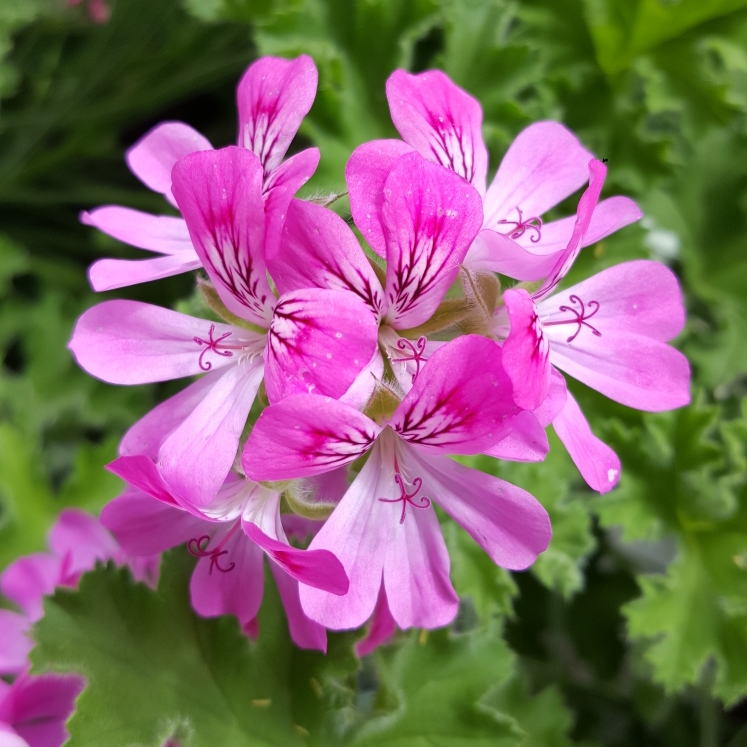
0, 674, 85, 747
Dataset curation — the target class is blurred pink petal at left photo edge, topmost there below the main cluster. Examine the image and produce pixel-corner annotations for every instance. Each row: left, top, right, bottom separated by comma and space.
0, 552, 65, 622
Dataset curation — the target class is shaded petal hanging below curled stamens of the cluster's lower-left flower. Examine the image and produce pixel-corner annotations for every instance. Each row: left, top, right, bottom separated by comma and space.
189, 525, 264, 625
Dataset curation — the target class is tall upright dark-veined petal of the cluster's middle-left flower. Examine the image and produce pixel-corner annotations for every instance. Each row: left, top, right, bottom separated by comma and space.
172, 146, 275, 328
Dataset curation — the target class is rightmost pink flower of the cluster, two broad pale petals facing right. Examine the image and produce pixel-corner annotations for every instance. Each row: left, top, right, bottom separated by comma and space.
493, 160, 690, 492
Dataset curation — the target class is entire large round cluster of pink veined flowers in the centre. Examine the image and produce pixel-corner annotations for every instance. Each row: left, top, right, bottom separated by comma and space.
70, 56, 689, 653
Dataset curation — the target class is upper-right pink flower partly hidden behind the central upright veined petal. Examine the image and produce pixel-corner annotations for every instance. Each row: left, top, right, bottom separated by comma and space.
346, 70, 641, 280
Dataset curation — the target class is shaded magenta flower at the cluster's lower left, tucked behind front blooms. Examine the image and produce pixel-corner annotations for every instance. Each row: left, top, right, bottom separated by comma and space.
101, 456, 348, 651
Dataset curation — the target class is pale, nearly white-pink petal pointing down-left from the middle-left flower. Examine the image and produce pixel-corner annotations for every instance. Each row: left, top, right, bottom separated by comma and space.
158, 360, 263, 507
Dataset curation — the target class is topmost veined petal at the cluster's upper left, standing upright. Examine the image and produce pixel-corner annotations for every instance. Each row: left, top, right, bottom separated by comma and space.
236, 55, 319, 176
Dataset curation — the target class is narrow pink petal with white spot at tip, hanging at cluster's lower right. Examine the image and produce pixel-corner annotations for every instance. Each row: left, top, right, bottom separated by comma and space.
552, 392, 620, 493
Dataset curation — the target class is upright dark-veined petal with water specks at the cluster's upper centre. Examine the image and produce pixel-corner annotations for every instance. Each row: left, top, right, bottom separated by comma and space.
382, 153, 482, 329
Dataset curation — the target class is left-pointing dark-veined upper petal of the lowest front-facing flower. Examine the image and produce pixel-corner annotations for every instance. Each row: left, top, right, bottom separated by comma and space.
242, 394, 381, 481
